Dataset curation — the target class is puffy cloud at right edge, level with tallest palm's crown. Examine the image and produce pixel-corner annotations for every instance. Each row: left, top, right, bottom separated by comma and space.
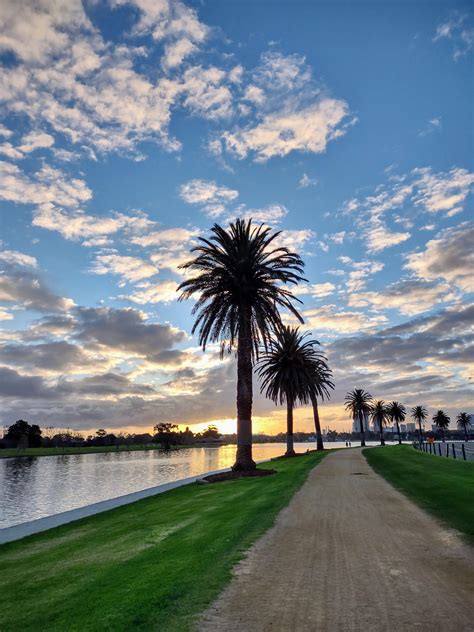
405, 223, 474, 292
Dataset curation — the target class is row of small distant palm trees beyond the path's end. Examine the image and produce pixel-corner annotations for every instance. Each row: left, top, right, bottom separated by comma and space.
345, 388, 471, 446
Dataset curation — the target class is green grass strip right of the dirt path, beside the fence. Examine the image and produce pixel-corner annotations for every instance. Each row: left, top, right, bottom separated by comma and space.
364, 445, 474, 544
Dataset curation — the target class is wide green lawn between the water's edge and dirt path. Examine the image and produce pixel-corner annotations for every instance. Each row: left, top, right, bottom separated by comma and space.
0, 453, 325, 632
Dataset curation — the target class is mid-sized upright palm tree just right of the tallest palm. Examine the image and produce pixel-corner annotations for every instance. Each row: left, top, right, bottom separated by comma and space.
258, 327, 312, 456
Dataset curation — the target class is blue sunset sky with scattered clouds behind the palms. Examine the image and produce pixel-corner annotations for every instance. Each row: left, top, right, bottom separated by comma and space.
0, 0, 474, 433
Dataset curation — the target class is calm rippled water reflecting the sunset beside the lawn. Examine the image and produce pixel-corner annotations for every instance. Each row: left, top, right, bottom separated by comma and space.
0, 442, 388, 528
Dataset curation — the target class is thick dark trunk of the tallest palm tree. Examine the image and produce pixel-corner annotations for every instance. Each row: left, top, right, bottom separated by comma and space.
232, 309, 256, 471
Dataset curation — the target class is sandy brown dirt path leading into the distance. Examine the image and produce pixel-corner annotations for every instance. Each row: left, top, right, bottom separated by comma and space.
199, 450, 474, 632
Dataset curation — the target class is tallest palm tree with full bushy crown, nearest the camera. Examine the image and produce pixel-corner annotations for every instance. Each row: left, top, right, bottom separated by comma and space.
178, 219, 305, 470
